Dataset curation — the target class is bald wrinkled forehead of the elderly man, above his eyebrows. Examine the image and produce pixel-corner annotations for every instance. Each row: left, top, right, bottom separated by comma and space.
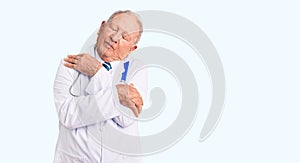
108, 13, 140, 34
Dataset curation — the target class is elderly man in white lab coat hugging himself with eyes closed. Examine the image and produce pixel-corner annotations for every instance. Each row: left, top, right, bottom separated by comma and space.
54, 10, 147, 163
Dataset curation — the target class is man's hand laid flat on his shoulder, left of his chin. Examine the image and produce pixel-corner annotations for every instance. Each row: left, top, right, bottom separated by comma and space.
64, 54, 102, 76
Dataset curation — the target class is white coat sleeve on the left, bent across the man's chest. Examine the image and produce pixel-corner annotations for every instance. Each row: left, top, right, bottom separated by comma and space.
53, 61, 120, 129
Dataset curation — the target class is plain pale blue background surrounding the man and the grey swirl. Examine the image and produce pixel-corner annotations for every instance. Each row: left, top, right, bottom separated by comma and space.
0, 0, 300, 163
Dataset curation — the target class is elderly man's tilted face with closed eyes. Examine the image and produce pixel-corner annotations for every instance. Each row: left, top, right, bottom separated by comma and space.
96, 13, 139, 62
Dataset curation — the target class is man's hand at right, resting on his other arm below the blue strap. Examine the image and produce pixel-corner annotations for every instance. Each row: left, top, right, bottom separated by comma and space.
116, 84, 143, 117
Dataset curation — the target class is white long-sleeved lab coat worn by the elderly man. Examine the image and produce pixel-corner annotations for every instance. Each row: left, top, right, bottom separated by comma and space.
54, 45, 147, 163
